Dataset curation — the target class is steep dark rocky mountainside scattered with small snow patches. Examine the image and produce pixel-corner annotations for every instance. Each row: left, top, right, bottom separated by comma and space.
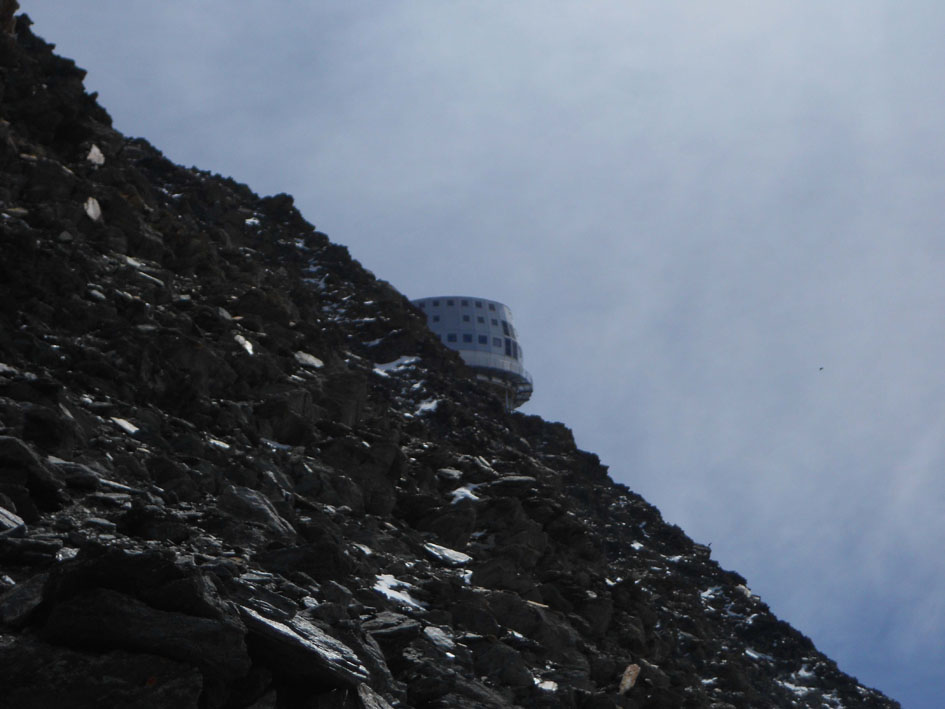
0, 9, 897, 709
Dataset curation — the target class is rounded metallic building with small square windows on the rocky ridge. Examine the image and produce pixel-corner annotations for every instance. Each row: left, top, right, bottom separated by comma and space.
412, 295, 532, 409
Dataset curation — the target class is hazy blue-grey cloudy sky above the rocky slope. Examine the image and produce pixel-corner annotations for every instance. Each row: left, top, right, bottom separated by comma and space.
27, 0, 945, 709
